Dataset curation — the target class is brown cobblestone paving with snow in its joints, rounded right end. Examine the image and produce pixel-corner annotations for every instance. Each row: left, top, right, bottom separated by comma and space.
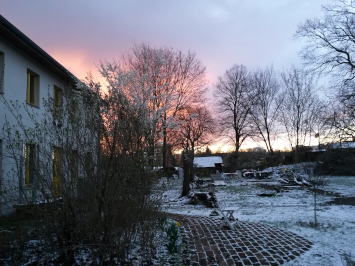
169, 214, 312, 266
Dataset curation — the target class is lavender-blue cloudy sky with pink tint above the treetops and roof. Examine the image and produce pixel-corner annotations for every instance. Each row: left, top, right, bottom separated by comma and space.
0, 0, 331, 88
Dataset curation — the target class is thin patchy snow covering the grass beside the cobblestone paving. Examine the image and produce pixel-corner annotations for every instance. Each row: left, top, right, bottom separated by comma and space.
164, 176, 355, 266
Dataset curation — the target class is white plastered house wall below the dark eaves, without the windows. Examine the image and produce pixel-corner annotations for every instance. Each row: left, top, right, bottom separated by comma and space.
0, 37, 70, 214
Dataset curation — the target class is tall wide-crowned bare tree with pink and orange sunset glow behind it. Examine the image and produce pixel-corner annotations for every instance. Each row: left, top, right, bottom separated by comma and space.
122, 43, 206, 172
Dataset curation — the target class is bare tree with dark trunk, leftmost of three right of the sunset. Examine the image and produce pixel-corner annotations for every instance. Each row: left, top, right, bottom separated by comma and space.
214, 65, 253, 167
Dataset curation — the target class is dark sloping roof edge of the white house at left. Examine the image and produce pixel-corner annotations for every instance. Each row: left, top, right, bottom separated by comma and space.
0, 15, 76, 83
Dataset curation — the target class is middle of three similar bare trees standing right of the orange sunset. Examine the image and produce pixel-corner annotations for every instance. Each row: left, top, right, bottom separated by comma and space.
249, 66, 283, 162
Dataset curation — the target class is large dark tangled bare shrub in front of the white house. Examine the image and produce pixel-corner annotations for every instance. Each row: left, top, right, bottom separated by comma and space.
2, 65, 164, 264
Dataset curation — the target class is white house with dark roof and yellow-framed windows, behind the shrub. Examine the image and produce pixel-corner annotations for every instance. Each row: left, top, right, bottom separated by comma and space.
0, 15, 75, 215
